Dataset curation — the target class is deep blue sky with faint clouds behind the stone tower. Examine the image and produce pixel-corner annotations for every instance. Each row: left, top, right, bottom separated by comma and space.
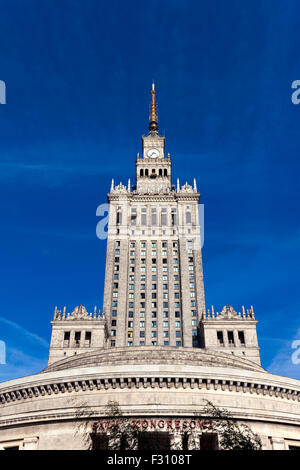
0, 0, 300, 381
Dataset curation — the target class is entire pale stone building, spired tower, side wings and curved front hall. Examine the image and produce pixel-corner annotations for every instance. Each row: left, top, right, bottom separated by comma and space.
0, 83, 300, 450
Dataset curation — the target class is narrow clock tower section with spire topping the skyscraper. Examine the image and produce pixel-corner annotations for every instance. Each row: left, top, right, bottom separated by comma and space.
136, 83, 171, 193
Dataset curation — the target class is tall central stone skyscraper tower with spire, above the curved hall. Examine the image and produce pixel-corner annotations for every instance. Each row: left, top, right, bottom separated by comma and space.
103, 83, 205, 347
